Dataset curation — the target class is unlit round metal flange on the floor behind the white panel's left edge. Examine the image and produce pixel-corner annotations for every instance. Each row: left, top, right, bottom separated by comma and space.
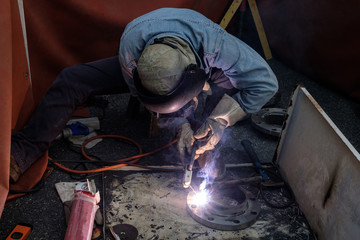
251, 108, 286, 137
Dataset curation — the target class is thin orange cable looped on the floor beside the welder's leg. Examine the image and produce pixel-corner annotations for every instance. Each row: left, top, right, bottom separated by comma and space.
48, 135, 178, 174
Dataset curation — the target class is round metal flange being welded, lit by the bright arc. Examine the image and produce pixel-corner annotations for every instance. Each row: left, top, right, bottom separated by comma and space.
187, 184, 260, 231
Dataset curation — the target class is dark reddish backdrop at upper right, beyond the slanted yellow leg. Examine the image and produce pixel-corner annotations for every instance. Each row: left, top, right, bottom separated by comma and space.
257, 0, 360, 102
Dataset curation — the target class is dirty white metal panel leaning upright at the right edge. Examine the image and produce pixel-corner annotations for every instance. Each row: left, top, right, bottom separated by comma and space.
275, 86, 360, 240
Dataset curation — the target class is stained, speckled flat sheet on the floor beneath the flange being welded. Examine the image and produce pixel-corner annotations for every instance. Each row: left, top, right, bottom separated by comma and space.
105, 173, 312, 239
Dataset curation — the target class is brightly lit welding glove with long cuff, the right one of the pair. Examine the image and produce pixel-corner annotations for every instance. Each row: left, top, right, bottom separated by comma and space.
194, 94, 247, 158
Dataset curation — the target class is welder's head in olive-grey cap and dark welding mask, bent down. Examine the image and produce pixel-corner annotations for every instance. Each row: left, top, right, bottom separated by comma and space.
133, 38, 207, 117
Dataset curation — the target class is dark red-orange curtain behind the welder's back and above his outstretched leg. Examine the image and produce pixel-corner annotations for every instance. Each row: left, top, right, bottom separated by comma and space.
24, 0, 229, 103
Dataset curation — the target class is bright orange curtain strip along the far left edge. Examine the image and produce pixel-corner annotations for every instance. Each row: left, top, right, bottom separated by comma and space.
0, 0, 32, 214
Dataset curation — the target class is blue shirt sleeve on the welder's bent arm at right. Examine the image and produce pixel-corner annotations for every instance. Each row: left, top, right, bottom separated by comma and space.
207, 33, 278, 113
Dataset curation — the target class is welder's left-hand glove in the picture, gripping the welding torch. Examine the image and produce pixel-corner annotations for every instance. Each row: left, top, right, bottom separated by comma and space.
177, 121, 194, 166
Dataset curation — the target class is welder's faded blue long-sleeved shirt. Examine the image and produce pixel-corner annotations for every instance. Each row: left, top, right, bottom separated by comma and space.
119, 8, 278, 113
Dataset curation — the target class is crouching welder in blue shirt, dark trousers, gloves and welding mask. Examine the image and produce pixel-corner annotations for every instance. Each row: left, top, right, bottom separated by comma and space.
11, 8, 278, 181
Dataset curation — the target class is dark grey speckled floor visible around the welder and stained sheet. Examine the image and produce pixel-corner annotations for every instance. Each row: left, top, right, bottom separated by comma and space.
0, 55, 360, 240
